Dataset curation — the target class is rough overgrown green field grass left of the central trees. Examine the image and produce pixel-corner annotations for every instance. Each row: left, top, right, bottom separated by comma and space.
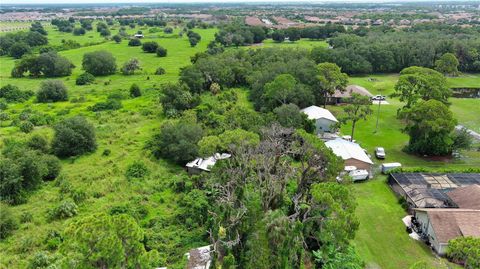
0, 25, 216, 268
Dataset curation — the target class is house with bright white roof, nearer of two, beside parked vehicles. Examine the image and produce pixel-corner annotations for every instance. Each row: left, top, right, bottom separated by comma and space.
325, 138, 373, 171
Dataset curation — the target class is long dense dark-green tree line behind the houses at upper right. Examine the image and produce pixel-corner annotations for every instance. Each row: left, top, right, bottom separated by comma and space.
312, 30, 480, 74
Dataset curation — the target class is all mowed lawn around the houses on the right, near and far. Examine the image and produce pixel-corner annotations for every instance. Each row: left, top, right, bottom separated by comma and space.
336, 74, 480, 269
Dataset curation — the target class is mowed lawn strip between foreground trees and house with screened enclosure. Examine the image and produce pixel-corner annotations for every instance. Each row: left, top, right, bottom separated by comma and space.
352, 176, 455, 269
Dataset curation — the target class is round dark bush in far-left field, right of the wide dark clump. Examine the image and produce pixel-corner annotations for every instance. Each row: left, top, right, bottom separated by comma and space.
82, 51, 117, 76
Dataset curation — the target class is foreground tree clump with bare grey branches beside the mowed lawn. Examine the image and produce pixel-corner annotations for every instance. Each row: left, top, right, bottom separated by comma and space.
202, 126, 358, 268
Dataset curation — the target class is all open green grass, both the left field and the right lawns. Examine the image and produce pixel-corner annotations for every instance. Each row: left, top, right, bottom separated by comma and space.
0, 22, 480, 269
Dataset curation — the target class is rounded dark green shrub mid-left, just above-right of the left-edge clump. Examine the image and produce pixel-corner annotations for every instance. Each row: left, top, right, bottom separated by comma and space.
52, 116, 97, 157
